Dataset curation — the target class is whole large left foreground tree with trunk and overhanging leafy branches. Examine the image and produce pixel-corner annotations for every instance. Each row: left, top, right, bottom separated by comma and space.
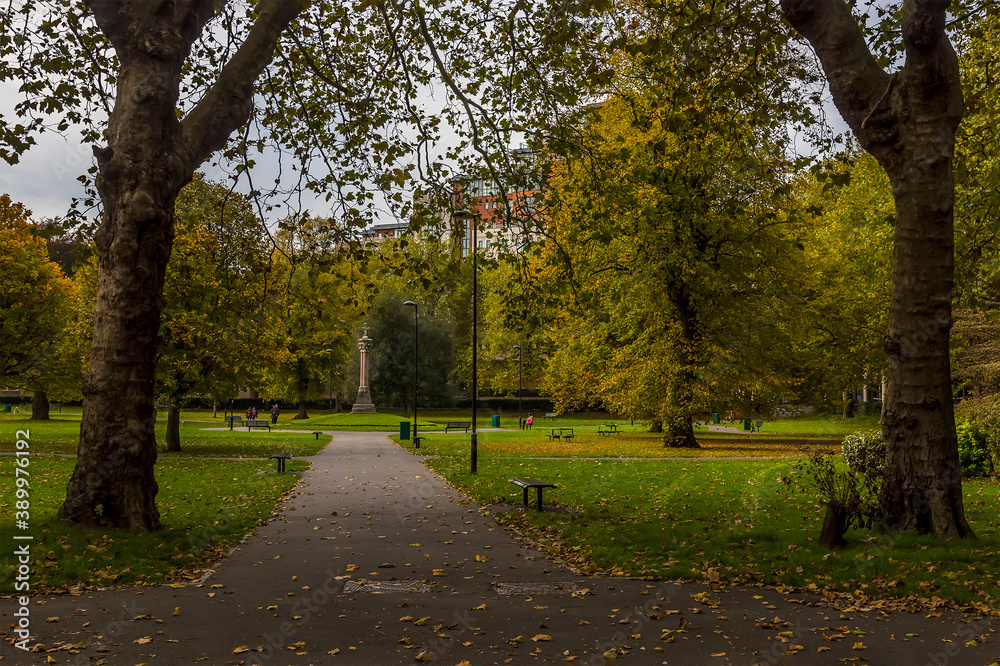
0, 0, 584, 530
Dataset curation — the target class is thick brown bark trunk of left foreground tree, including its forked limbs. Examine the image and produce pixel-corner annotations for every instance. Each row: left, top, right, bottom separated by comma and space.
59, 0, 302, 531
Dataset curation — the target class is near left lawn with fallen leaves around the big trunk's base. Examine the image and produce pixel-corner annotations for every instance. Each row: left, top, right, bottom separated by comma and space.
0, 456, 308, 594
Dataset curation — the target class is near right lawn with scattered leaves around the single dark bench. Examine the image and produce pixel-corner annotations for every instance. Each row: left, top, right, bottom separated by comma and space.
425, 455, 1000, 608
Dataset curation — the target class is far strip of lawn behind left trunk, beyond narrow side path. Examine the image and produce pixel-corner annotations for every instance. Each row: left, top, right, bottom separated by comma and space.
0, 418, 330, 459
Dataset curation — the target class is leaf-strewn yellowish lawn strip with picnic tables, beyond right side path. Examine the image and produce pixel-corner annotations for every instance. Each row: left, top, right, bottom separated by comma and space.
392, 428, 840, 458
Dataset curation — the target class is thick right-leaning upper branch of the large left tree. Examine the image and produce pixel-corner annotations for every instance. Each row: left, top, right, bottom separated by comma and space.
180, 0, 308, 169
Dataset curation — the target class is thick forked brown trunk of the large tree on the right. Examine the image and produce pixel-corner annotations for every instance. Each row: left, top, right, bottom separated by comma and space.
781, 0, 974, 537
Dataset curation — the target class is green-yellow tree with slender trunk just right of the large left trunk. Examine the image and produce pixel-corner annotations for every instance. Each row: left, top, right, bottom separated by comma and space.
157, 174, 278, 451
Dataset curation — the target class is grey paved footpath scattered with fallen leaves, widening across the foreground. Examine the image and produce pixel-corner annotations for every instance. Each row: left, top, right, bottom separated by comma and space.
0, 433, 1000, 666
